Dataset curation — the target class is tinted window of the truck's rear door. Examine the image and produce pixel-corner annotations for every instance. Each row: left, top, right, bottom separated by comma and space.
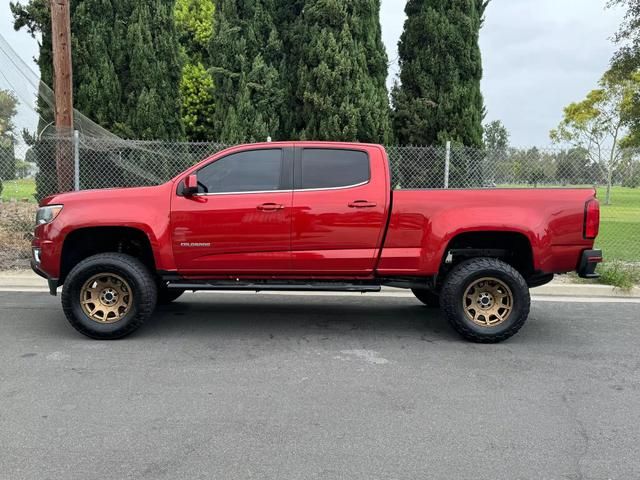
296, 148, 370, 190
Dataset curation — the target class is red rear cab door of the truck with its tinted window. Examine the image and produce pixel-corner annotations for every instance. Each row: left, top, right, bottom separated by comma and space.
291, 146, 389, 276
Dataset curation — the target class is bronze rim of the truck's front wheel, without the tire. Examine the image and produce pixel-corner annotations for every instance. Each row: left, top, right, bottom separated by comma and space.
80, 273, 133, 323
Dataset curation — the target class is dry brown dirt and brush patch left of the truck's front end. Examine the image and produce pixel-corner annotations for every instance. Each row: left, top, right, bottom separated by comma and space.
0, 202, 37, 270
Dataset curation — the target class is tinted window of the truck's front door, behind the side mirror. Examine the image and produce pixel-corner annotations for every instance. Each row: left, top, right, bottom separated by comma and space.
198, 149, 282, 193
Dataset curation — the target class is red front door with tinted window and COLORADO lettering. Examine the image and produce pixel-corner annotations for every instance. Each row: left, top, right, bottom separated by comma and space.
171, 148, 293, 276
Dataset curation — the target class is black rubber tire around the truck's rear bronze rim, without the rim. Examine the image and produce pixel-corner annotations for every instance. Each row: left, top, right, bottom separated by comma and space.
440, 258, 531, 343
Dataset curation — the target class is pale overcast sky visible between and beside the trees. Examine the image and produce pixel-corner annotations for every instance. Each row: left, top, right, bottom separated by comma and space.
0, 0, 623, 147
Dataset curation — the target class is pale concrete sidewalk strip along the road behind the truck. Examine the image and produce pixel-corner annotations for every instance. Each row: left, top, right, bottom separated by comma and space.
0, 270, 640, 298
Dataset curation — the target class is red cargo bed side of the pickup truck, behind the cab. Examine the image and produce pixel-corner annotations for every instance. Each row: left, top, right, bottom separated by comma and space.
377, 188, 596, 276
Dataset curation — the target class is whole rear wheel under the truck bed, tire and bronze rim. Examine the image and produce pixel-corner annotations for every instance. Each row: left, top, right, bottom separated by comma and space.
440, 258, 531, 343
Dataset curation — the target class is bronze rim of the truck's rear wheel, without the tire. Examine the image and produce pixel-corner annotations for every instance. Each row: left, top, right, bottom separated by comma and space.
462, 277, 513, 327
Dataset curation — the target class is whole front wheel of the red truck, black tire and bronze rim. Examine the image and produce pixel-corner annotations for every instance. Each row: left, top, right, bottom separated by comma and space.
62, 253, 157, 340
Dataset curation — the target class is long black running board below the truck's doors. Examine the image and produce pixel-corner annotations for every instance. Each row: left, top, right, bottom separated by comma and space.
167, 281, 382, 293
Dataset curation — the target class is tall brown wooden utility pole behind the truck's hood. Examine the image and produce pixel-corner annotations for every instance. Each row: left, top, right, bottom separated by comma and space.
51, 0, 74, 192
